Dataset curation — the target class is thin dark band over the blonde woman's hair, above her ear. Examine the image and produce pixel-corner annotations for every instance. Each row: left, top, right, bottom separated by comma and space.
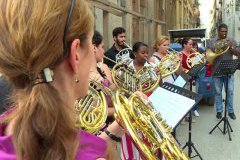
63, 0, 75, 57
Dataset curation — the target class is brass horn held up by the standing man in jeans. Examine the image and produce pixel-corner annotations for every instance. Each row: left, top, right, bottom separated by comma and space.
206, 38, 229, 64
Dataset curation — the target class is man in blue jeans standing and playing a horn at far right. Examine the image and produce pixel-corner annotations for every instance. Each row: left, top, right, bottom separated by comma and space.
207, 24, 239, 119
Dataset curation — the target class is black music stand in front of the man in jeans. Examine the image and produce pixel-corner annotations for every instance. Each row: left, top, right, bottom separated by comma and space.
209, 59, 240, 141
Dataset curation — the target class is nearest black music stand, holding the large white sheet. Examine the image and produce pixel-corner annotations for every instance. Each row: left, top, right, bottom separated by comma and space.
159, 82, 202, 160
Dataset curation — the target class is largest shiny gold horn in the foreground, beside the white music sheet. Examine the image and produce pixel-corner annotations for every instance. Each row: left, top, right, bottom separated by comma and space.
113, 89, 189, 160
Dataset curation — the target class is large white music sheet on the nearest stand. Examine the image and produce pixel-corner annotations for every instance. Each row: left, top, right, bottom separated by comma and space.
148, 87, 195, 128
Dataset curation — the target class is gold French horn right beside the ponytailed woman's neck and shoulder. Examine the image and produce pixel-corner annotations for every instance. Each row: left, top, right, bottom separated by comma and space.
75, 81, 108, 134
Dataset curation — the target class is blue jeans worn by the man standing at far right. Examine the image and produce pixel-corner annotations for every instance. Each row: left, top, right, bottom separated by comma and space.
214, 75, 234, 113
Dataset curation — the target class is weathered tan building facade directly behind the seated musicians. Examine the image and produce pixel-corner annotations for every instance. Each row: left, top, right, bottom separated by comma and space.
88, 0, 200, 48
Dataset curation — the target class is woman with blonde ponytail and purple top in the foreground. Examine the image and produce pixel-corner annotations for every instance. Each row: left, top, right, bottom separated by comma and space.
0, 0, 123, 160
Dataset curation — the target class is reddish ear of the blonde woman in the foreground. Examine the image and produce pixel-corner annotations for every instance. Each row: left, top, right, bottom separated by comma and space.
69, 39, 80, 74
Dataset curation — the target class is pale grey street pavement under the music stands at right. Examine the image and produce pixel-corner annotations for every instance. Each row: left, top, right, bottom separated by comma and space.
176, 71, 240, 160
